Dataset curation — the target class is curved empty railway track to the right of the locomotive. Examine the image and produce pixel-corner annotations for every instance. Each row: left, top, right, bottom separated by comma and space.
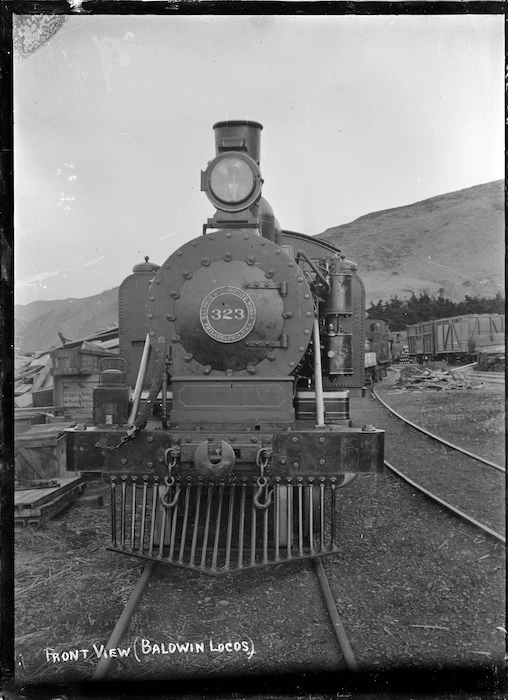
372, 389, 506, 543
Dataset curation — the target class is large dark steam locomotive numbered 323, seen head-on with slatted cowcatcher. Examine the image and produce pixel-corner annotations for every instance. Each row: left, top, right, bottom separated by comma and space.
67, 121, 384, 574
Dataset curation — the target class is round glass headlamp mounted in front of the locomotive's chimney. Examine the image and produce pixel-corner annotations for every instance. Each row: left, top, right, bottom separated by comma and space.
201, 151, 262, 212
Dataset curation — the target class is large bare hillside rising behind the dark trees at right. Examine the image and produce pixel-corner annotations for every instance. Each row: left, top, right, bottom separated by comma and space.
318, 180, 505, 303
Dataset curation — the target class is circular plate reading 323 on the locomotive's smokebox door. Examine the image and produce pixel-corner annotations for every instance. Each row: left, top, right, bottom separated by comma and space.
199, 287, 256, 343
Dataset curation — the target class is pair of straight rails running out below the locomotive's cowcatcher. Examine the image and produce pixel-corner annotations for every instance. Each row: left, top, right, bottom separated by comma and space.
92, 557, 360, 681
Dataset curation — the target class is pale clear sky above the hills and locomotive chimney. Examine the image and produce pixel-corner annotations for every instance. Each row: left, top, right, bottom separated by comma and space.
14, 15, 504, 304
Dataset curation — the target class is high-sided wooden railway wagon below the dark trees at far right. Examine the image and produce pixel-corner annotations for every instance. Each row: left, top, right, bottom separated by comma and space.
407, 314, 504, 364
